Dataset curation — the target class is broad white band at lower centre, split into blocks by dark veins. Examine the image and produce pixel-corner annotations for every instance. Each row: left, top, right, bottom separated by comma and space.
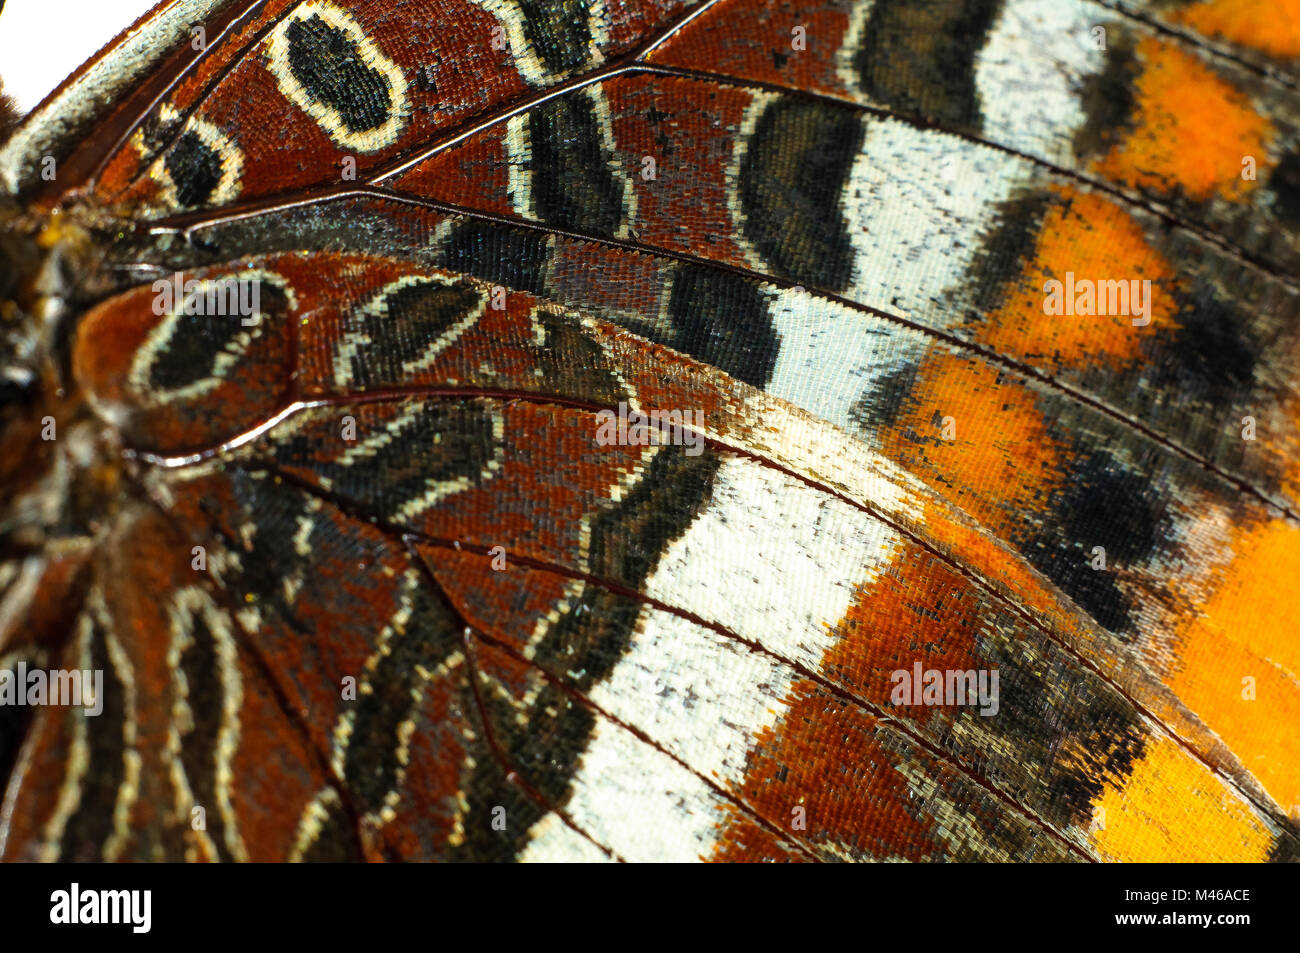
533, 458, 898, 861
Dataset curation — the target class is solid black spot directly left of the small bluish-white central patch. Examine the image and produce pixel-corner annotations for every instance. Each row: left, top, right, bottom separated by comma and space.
657, 264, 780, 387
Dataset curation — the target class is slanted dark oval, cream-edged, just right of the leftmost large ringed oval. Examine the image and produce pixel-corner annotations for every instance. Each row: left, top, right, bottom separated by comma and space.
343, 281, 482, 389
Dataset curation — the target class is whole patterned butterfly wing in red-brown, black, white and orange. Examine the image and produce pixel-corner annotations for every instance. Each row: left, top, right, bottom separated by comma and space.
0, 0, 1300, 862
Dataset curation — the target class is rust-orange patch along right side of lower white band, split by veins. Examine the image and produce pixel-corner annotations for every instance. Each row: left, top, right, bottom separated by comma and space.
714, 546, 1013, 861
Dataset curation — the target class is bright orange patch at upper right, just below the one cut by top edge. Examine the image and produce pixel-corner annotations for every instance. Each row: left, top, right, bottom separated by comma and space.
1095, 38, 1273, 202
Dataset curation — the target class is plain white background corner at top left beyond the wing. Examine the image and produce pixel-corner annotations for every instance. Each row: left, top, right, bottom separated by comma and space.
0, 0, 156, 112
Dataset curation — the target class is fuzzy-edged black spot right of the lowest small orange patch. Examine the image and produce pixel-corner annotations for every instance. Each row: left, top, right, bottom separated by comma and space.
1021, 447, 1167, 633
